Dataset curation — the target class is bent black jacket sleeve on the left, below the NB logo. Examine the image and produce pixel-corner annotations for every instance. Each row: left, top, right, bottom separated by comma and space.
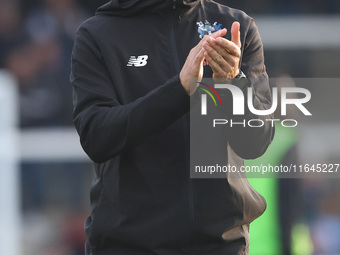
71, 27, 190, 163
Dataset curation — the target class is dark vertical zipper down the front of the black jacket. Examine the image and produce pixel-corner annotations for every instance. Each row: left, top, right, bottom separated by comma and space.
170, 5, 196, 255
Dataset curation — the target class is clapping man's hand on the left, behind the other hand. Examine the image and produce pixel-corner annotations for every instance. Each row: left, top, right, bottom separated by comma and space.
179, 28, 227, 96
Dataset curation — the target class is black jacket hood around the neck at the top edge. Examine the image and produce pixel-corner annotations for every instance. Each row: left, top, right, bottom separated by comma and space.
96, 0, 200, 16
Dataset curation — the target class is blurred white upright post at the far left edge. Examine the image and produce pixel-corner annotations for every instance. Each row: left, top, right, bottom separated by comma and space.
0, 70, 22, 255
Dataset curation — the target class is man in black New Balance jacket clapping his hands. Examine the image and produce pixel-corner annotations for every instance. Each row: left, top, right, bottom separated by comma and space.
71, 0, 273, 255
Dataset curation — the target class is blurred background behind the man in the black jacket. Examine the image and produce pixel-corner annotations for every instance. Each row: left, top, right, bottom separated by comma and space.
0, 0, 340, 255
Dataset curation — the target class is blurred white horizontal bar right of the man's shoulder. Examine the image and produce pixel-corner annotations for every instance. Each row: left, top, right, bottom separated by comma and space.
255, 15, 340, 50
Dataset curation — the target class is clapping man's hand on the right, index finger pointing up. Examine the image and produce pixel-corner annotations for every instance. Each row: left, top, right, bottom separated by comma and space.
203, 22, 241, 79
